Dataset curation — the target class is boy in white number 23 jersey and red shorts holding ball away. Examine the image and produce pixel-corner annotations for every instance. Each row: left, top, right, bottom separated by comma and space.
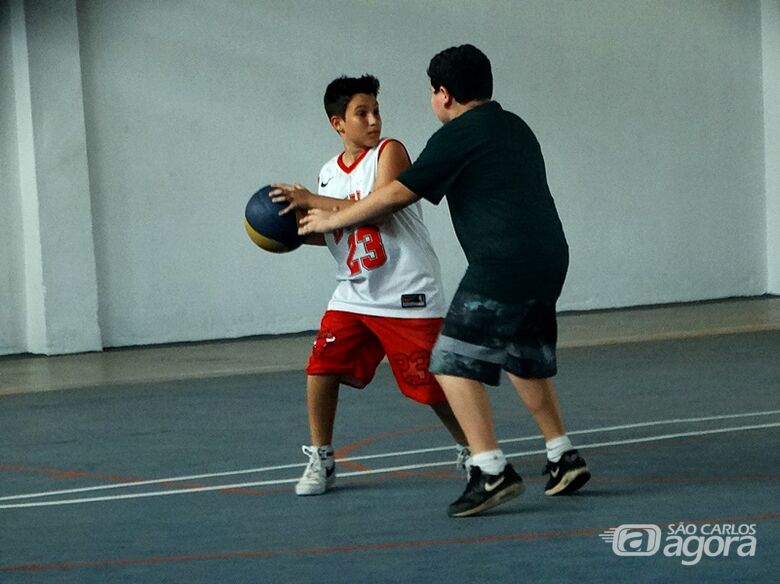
271, 75, 469, 495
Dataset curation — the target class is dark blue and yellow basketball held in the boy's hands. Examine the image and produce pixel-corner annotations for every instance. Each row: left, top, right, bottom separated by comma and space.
244, 185, 304, 253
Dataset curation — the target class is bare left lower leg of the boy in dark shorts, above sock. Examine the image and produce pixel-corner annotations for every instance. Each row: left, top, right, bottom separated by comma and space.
436, 375, 498, 454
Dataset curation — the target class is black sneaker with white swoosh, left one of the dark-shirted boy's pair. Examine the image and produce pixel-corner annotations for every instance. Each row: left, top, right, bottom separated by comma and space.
447, 464, 525, 517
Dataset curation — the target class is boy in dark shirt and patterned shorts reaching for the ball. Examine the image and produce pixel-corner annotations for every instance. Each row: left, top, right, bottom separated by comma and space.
284, 45, 590, 517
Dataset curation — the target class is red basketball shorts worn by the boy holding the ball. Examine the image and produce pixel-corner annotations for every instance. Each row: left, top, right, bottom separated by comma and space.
306, 310, 446, 404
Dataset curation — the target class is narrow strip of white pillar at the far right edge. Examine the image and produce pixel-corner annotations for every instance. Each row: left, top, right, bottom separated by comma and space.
761, 0, 780, 294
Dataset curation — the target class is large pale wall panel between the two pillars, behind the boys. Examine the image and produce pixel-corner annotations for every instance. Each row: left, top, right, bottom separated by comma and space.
0, 0, 777, 352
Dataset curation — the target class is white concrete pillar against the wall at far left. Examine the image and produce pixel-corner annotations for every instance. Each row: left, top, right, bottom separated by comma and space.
10, 0, 102, 354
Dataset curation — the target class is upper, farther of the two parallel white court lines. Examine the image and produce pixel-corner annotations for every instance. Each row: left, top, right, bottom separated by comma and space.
0, 410, 780, 501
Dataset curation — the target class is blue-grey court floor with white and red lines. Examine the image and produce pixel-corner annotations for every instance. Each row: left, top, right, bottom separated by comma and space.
0, 318, 780, 583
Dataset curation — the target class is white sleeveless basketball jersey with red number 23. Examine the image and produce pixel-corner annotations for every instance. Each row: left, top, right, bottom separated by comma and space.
317, 139, 445, 318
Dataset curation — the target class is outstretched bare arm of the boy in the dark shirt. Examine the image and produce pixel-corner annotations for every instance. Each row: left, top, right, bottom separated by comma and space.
298, 180, 420, 235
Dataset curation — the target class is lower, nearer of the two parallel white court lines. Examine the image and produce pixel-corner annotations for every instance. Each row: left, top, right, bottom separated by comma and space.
0, 422, 780, 509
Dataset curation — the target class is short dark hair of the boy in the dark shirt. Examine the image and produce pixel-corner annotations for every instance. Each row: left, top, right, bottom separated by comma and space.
428, 45, 493, 103
